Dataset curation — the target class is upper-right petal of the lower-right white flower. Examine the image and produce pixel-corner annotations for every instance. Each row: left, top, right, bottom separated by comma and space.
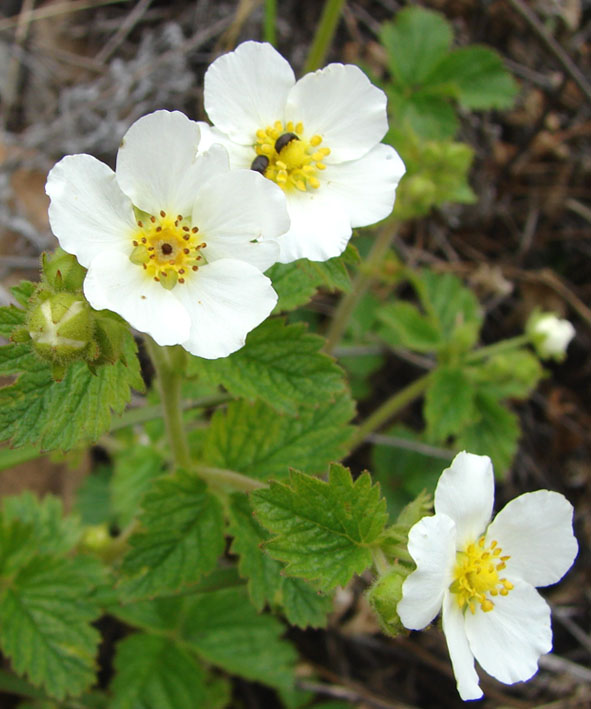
486, 490, 578, 586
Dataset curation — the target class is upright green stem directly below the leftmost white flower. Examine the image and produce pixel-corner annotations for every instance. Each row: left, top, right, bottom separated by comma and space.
145, 337, 191, 470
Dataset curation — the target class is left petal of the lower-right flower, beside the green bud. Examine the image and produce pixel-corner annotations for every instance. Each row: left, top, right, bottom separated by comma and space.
397, 515, 456, 630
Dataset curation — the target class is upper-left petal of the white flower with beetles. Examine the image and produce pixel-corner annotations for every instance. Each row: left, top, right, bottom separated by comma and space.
203, 42, 295, 145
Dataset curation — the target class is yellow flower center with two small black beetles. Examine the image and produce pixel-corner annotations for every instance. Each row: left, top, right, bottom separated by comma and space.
251, 121, 330, 192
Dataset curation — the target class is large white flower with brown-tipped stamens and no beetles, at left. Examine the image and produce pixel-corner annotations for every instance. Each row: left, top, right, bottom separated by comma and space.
46, 111, 289, 359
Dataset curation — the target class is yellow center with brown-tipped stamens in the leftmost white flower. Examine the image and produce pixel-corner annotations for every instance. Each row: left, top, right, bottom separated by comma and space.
129, 211, 207, 290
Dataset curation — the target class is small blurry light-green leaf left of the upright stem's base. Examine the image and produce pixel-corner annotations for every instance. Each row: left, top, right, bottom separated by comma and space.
110, 444, 165, 527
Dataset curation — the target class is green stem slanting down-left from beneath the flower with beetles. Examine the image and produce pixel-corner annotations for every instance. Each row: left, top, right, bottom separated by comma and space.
324, 224, 396, 354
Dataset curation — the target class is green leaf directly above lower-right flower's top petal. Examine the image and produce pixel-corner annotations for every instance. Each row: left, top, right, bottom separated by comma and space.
456, 391, 521, 476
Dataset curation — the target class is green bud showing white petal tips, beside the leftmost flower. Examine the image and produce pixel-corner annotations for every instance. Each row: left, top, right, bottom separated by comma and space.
28, 292, 94, 365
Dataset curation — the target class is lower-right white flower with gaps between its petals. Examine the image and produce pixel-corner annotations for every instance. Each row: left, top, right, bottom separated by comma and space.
398, 452, 578, 700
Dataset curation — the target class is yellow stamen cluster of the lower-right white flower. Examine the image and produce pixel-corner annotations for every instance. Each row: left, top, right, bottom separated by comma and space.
449, 537, 513, 613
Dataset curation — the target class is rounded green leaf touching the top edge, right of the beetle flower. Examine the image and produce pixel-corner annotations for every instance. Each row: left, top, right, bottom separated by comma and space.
380, 7, 453, 87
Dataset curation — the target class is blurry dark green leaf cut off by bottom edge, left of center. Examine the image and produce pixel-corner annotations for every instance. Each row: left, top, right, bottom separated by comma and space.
110, 633, 208, 709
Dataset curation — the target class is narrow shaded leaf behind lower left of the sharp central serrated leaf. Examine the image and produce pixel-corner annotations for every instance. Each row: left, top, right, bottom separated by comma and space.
230, 494, 332, 628
